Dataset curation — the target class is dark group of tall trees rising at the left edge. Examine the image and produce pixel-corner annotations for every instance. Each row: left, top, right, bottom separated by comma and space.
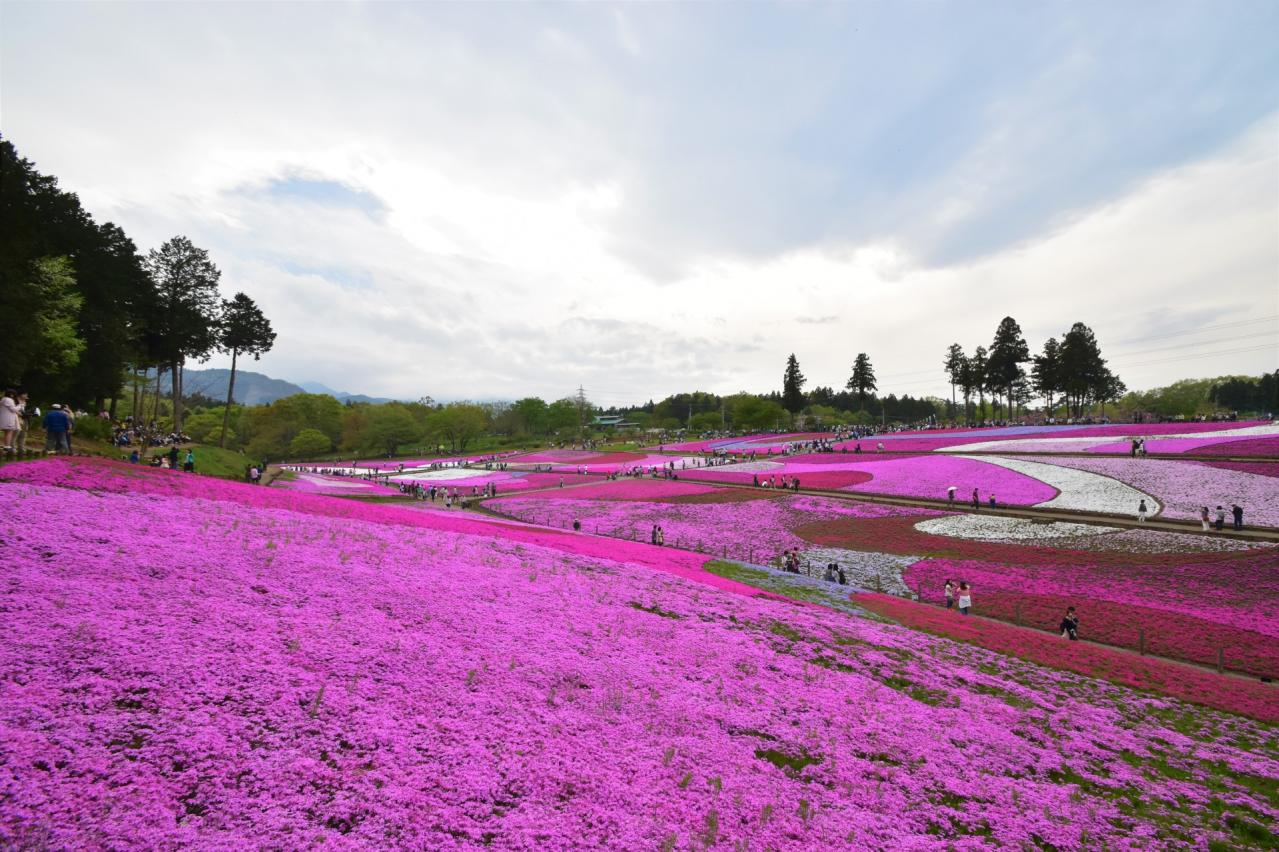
0, 139, 275, 440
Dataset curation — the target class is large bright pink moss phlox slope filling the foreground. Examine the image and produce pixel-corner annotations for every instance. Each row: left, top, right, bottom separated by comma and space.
0, 462, 1279, 849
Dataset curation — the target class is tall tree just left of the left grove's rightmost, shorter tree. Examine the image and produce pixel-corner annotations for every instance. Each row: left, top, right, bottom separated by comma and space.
147, 237, 223, 431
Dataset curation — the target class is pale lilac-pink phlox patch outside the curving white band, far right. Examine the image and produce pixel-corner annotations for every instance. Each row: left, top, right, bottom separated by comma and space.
1012, 455, 1279, 527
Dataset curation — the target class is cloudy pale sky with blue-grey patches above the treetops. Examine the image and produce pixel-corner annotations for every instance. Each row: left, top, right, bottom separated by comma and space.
0, 0, 1279, 406
